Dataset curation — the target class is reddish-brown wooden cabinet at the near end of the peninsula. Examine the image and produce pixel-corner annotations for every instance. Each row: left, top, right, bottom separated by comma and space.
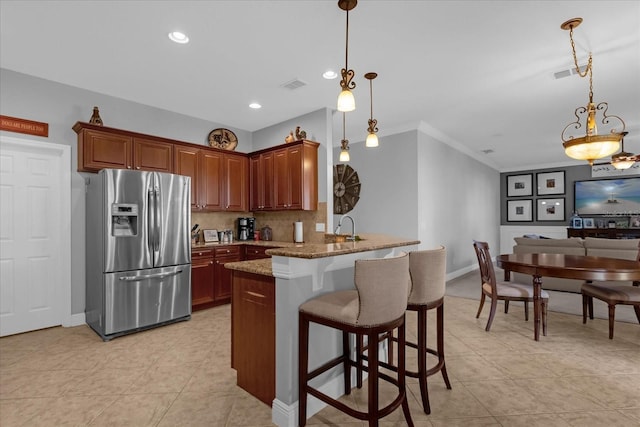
231, 270, 276, 406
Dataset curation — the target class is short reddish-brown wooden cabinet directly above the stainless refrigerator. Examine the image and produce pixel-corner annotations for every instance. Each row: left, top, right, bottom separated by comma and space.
73, 122, 173, 172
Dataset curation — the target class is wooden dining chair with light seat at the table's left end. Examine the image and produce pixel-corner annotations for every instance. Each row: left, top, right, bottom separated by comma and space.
473, 240, 549, 335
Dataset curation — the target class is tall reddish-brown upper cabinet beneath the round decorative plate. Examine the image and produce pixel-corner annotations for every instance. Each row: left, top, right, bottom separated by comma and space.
174, 145, 249, 212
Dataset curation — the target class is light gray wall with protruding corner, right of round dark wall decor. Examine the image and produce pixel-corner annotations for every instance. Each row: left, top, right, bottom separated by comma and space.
333, 130, 500, 274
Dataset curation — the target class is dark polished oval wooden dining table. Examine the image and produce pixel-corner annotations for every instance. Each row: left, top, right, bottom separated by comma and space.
496, 254, 640, 341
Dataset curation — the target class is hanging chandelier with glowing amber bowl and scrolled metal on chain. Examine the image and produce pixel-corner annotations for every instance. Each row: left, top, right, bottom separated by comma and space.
560, 18, 630, 166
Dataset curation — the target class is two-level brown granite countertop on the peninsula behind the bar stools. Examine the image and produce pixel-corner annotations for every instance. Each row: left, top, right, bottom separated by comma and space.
225, 234, 420, 276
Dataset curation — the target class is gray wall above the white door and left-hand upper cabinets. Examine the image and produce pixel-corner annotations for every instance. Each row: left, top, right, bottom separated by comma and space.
0, 69, 253, 314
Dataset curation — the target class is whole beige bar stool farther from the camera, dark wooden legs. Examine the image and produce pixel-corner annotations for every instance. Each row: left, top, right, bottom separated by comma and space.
357, 246, 451, 414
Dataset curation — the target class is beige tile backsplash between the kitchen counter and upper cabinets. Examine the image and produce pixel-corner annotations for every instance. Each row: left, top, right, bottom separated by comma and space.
191, 202, 327, 243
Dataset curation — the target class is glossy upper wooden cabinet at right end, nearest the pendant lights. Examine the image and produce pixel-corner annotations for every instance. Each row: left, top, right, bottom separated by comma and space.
273, 140, 320, 211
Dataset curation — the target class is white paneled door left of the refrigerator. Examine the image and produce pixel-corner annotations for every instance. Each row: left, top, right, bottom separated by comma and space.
0, 136, 71, 336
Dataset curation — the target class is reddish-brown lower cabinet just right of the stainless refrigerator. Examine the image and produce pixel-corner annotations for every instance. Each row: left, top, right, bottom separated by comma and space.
191, 245, 243, 311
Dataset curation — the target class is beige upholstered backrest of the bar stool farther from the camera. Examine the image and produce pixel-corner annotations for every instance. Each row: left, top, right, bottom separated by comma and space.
409, 246, 447, 305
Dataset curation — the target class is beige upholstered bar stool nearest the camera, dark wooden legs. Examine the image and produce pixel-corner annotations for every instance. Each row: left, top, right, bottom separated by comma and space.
298, 254, 413, 426
